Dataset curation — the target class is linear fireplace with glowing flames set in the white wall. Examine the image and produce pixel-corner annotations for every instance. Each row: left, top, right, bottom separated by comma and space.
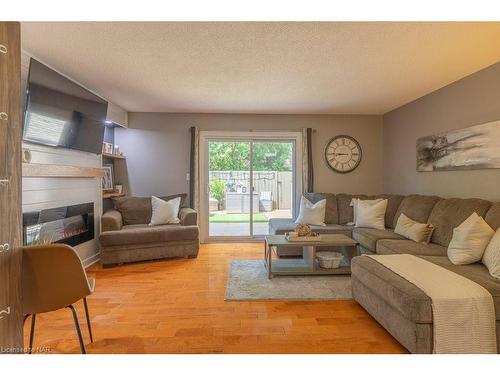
23, 203, 94, 246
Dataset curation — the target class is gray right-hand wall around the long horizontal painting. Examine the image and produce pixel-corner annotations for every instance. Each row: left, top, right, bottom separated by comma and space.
383, 63, 500, 201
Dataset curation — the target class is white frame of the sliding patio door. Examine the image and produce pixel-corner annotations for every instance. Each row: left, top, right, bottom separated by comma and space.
199, 130, 302, 243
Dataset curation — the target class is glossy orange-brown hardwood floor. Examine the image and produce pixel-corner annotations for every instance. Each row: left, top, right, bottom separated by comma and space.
24, 243, 406, 353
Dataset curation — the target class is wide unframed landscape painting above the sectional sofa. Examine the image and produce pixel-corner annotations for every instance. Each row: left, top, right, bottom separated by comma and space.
417, 120, 500, 172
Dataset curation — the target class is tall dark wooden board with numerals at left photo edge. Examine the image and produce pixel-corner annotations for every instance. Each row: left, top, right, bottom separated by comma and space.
0, 22, 23, 353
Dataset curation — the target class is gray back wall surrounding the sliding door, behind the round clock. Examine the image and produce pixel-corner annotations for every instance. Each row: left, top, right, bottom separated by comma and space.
115, 113, 383, 196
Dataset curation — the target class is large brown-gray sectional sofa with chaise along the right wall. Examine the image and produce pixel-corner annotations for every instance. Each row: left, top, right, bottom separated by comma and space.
269, 193, 500, 353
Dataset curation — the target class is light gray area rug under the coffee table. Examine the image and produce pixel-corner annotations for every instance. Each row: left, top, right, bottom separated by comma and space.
224, 260, 352, 301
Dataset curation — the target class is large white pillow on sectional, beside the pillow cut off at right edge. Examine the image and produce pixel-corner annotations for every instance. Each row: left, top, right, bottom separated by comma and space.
448, 212, 495, 264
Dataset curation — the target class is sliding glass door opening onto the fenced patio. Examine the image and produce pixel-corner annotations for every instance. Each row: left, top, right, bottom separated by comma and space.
201, 135, 296, 240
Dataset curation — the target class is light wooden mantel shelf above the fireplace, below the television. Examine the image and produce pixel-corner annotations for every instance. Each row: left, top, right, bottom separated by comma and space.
23, 163, 104, 178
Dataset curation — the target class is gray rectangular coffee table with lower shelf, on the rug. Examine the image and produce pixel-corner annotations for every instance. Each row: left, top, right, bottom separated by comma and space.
264, 234, 359, 279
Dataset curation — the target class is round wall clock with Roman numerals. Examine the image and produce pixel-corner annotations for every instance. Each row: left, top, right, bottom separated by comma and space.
325, 135, 361, 173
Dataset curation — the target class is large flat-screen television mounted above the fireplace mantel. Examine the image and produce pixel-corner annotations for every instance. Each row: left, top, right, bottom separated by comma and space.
23, 59, 108, 154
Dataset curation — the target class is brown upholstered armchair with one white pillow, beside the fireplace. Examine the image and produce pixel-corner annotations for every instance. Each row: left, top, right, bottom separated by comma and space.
99, 194, 200, 266
